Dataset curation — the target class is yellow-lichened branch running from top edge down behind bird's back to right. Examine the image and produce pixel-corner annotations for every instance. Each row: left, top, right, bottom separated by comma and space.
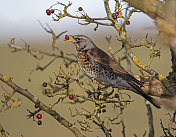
48, 0, 176, 95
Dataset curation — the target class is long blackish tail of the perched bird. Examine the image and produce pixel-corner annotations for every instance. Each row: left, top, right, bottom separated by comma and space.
129, 83, 161, 108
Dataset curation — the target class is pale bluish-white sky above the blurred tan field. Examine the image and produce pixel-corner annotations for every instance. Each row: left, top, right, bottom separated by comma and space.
0, 0, 156, 45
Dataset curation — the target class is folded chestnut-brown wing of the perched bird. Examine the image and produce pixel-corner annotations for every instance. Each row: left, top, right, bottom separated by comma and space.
88, 48, 143, 86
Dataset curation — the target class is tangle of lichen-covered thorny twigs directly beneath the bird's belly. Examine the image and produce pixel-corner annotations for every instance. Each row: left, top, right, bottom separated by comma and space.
45, 65, 132, 137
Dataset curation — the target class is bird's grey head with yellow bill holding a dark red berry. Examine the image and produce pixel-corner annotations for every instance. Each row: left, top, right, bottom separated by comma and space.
66, 35, 96, 51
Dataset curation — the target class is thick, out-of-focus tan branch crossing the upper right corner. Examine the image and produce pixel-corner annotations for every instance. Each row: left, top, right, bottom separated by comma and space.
124, 0, 176, 47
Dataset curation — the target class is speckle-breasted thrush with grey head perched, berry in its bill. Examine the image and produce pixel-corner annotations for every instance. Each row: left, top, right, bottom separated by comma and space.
65, 35, 161, 108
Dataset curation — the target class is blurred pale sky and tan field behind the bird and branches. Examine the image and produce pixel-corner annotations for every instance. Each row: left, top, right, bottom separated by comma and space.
0, 0, 171, 137
